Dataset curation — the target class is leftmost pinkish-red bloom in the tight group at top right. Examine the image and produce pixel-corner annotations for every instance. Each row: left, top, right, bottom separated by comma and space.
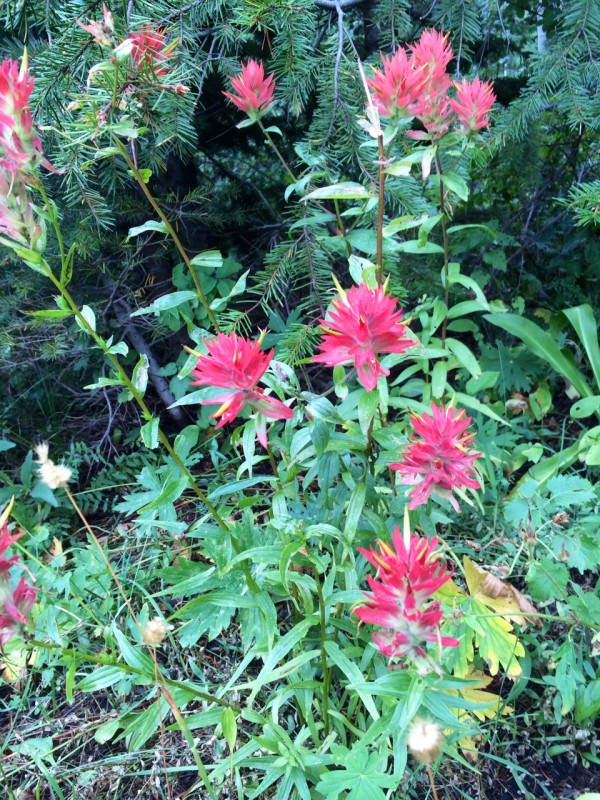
367, 47, 428, 117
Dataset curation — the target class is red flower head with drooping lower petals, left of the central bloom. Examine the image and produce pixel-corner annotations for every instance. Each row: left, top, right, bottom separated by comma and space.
192, 333, 294, 448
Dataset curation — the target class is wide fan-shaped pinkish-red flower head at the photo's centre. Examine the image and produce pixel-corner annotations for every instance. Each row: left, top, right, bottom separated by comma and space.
313, 283, 414, 392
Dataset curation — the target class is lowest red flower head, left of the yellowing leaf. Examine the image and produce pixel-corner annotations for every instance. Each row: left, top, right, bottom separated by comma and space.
354, 528, 458, 658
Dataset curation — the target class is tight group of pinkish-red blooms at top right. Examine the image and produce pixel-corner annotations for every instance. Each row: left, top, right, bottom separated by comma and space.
368, 30, 496, 137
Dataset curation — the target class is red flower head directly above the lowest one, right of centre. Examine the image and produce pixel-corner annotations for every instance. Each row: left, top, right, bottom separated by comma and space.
390, 403, 481, 511
